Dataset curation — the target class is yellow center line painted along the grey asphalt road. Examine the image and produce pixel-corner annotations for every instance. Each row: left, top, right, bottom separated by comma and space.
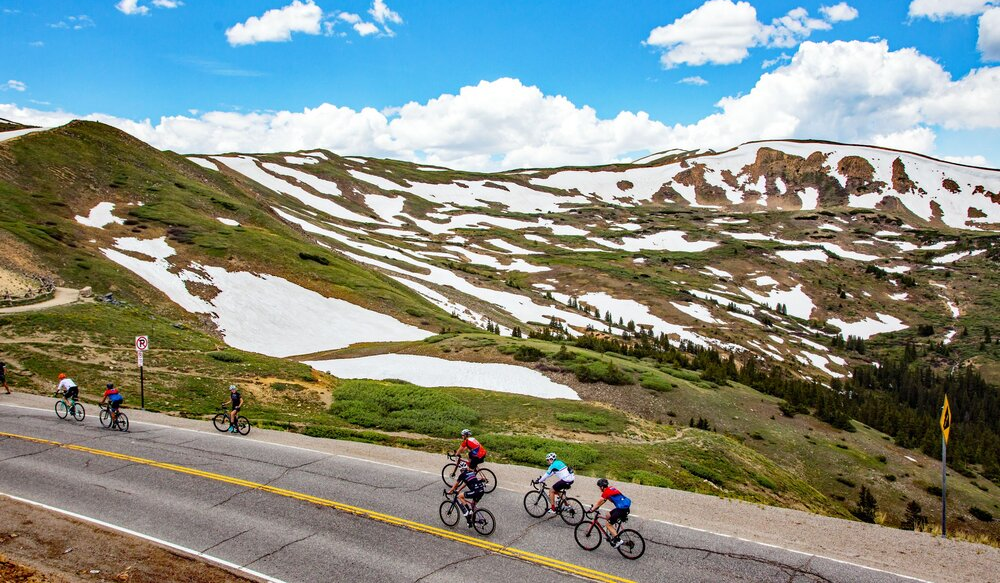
0, 431, 635, 583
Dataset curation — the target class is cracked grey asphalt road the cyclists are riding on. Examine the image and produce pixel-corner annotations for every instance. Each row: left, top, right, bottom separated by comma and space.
0, 404, 936, 583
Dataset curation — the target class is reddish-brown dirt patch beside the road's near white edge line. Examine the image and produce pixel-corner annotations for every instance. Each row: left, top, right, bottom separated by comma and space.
0, 497, 255, 583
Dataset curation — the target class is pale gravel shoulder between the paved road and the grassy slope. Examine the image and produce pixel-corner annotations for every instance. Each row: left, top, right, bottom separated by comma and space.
0, 393, 1000, 583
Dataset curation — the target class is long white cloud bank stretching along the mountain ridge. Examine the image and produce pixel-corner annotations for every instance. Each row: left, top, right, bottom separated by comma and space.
0, 41, 1000, 170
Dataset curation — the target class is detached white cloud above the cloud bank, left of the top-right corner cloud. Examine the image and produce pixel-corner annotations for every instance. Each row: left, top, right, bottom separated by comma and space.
645, 0, 857, 69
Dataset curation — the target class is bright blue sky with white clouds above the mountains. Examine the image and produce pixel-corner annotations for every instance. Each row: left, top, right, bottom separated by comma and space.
0, 0, 1000, 167
